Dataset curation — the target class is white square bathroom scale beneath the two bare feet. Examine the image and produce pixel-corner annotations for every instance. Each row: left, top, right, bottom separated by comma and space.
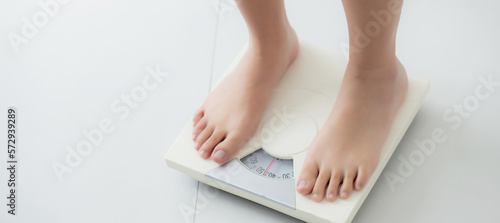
165, 41, 429, 223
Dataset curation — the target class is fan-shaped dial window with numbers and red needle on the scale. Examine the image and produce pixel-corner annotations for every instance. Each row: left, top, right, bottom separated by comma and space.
240, 149, 293, 179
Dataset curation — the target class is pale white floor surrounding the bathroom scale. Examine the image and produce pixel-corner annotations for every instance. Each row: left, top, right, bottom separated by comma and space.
0, 0, 500, 223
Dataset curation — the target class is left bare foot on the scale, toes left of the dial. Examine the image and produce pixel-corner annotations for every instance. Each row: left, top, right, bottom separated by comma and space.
193, 27, 299, 163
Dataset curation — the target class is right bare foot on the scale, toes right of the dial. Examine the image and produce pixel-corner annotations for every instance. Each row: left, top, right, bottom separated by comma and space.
297, 58, 408, 201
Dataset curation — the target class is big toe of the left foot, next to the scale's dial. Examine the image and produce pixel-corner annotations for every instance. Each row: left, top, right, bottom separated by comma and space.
212, 134, 245, 163
